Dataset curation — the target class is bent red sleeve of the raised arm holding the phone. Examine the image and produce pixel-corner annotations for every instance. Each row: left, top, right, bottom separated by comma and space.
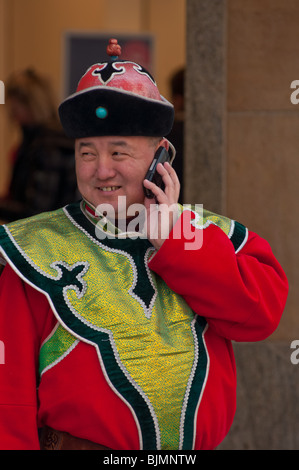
149, 211, 288, 341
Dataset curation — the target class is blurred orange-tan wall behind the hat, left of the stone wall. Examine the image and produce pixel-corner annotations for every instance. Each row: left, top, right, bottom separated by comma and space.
0, 0, 186, 192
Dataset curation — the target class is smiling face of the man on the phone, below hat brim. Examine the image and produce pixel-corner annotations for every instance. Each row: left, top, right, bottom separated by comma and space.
75, 136, 161, 216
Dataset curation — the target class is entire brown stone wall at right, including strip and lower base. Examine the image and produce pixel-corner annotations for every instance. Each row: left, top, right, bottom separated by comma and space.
185, 0, 299, 450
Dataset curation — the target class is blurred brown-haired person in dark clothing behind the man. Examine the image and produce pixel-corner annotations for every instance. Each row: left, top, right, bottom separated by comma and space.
0, 69, 77, 222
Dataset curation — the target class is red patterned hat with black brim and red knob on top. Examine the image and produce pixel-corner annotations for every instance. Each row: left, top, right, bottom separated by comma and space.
59, 39, 174, 139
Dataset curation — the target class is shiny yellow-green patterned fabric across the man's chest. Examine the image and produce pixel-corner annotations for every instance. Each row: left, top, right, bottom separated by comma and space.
2, 201, 212, 449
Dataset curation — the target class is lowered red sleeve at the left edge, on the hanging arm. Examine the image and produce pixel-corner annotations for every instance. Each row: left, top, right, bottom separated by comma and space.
0, 265, 54, 450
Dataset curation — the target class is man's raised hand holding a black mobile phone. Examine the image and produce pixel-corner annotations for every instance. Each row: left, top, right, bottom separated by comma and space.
143, 162, 180, 250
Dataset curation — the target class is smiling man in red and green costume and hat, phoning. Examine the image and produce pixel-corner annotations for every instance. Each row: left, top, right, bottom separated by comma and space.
0, 39, 288, 450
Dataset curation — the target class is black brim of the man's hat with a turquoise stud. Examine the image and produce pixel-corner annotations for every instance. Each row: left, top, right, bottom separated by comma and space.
59, 86, 174, 139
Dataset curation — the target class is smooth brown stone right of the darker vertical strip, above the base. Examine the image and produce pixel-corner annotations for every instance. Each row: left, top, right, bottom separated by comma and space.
226, 0, 299, 339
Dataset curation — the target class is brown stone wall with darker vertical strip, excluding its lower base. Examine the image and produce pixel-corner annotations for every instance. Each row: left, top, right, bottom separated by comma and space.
185, 0, 299, 340
